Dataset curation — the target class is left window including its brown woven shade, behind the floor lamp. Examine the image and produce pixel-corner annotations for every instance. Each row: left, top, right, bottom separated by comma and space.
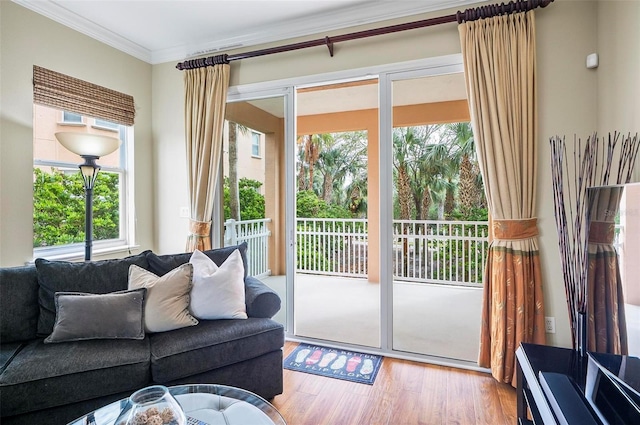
33, 65, 135, 258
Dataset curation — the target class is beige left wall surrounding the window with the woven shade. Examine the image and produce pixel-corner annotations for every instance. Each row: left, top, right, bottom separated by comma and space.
0, 1, 154, 266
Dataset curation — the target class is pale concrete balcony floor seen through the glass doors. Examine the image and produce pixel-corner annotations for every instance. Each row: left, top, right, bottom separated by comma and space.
262, 273, 482, 364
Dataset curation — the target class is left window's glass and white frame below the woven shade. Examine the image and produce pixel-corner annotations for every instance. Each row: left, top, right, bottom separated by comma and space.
33, 105, 133, 257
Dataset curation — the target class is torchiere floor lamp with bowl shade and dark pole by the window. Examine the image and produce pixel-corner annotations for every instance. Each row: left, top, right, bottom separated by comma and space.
55, 132, 120, 261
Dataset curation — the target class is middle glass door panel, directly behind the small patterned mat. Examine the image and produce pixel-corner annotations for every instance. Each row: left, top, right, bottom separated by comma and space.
294, 79, 380, 347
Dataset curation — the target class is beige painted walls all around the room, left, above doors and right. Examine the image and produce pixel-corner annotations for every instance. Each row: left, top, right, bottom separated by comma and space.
0, 0, 640, 346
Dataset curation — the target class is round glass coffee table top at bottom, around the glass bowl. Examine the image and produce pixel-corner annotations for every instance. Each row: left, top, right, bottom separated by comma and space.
68, 384, 286, 425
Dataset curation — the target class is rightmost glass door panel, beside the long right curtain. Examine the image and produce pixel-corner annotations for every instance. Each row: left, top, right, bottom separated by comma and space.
391, 73, 486, 362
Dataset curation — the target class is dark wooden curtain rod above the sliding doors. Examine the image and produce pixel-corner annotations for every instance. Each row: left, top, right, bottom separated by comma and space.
176, 0, 553, 71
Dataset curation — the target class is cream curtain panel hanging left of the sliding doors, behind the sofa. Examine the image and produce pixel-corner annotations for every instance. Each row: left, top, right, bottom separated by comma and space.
184, 63, 229, 248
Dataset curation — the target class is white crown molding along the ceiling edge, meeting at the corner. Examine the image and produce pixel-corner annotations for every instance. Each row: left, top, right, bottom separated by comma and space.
13, 0, 481, 65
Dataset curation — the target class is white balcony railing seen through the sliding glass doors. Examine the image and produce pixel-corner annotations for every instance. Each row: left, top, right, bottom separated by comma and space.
225, 218, 489, 286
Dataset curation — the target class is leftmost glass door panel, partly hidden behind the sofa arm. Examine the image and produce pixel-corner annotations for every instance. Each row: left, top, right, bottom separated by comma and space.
223, 97, 287, 324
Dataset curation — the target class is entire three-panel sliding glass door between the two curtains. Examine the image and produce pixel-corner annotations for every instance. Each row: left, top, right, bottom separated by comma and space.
225, 56, 488, 367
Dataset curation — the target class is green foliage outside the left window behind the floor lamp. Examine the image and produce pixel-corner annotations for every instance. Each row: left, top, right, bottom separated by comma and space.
33, 168, 120, 248
